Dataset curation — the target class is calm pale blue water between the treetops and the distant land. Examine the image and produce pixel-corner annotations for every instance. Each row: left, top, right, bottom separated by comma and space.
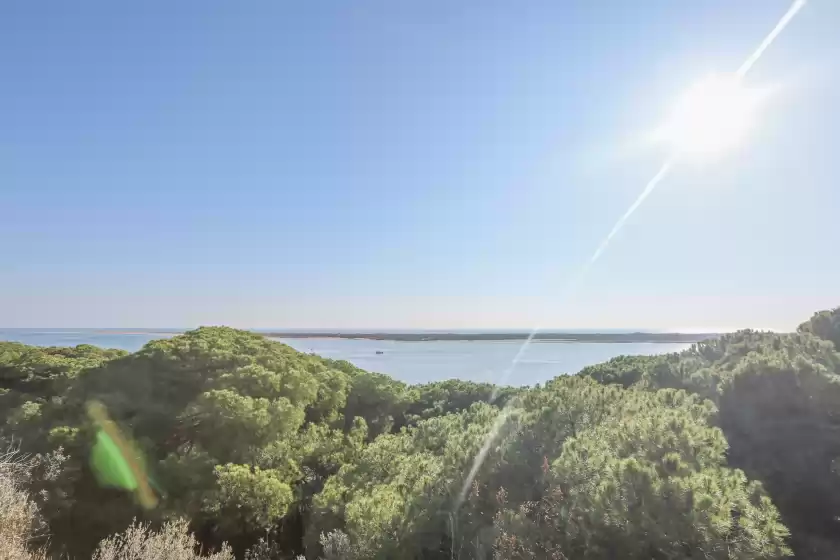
0, 329, 689, 385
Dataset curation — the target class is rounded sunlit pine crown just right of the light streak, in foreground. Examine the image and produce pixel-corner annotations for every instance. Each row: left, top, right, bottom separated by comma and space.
524, 400, 787, 559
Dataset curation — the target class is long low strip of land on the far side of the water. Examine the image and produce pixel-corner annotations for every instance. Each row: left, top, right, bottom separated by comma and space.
257, 331, 720, 344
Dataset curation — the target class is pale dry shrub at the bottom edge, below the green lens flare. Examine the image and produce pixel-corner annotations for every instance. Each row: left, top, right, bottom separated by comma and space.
93, 520, 234, 560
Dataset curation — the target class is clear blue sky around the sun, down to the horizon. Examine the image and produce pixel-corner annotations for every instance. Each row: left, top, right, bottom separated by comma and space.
0, 0, 840, 328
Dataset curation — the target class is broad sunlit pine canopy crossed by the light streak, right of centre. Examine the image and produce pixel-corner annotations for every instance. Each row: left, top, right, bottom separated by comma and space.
313, 378, 787, 558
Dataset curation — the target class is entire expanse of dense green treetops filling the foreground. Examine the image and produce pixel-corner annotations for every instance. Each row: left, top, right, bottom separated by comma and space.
0, 309, 840, 560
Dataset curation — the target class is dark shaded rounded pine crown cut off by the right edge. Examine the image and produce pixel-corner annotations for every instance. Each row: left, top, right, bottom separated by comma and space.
720, 355, 840, 558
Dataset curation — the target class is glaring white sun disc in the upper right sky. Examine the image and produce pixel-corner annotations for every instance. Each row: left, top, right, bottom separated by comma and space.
657, 75, 762, 159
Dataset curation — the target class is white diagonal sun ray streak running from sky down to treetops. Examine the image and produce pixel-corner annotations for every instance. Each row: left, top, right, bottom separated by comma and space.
454, 0, 806, 511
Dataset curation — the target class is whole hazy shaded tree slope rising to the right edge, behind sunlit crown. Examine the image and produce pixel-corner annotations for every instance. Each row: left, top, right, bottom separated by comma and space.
584, 309, 840, 558
